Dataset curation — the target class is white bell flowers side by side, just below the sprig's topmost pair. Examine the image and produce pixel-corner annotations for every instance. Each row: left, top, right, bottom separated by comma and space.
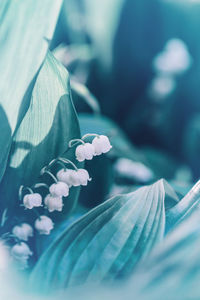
57, 169, 91, 187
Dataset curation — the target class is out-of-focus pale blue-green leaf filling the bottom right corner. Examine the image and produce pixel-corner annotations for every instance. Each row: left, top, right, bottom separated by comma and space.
129, 210, 200, 300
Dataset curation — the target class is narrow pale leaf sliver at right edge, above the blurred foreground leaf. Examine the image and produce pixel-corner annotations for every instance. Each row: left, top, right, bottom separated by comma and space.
166, 180, 200, 231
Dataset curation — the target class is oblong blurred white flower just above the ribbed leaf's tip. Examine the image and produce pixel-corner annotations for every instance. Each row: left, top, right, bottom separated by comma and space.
115, 158, 154, 183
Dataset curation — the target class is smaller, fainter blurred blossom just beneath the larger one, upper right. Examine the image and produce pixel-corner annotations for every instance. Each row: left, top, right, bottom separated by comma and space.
149, 75, 176, 100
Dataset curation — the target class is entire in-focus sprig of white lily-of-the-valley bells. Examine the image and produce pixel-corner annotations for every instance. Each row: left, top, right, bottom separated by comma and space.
11, 135, 112, 267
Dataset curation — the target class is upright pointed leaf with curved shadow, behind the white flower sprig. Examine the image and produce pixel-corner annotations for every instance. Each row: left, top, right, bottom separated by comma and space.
0, 52, 80, 216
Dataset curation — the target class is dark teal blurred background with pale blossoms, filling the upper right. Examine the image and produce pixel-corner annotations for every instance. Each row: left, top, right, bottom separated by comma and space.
48, 0, 200, 179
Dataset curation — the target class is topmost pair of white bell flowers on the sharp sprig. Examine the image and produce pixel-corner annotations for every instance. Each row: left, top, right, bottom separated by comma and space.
75, 135, 112, 162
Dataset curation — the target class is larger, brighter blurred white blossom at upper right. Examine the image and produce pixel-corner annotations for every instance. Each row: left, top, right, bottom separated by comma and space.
153, 39, 192, 75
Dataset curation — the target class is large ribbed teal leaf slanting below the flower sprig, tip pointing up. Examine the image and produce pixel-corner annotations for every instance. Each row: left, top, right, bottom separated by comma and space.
31, 180, 165, 291
